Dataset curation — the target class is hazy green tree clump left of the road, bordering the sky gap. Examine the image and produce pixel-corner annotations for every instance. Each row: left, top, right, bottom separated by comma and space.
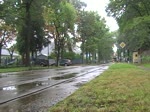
78, 11, 113, 63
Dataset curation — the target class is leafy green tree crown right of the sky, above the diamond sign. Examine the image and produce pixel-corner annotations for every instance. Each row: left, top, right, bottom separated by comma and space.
106, 0, 150, 53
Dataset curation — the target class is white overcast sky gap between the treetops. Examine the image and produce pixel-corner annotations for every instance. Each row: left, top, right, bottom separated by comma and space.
81, 0, 118, 31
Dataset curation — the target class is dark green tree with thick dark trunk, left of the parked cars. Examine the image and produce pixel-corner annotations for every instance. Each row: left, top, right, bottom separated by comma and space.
17, 0, 44, 66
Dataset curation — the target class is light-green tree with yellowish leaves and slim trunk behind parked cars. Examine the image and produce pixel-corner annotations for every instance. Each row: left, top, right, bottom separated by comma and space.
44, 0, 76, 66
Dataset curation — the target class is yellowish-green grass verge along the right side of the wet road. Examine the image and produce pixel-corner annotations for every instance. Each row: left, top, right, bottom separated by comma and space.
49, 63, 150, 112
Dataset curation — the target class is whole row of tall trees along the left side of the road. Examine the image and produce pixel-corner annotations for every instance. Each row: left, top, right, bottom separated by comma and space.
0, 0, 113, 66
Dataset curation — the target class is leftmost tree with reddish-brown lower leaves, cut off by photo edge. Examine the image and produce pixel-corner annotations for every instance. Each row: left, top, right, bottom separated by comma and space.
0, 0, 16, 65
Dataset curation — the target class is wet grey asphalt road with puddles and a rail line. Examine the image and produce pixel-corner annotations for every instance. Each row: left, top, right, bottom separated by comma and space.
0, 65, 109, 112
